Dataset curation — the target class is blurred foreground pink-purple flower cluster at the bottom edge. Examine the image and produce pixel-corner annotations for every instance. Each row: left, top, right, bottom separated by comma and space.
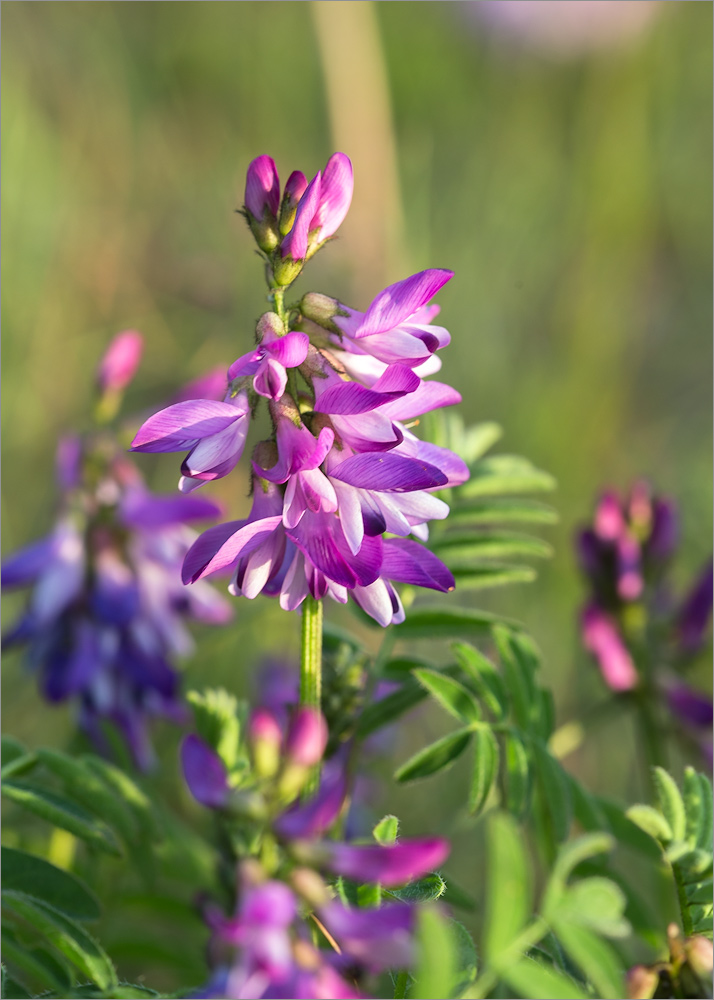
182, 707, 448, 998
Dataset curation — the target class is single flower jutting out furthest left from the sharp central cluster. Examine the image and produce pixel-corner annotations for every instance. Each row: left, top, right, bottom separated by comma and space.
131, 391, 250, 493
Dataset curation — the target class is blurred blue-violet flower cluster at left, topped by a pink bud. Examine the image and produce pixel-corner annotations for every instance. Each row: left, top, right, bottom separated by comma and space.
2, 332, 231, 767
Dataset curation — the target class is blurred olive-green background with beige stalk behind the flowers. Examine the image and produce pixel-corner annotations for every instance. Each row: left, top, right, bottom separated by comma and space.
2, 0, 712, 992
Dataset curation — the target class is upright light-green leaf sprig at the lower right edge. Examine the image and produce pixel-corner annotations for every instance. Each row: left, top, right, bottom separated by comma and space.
627, 767, 713, 937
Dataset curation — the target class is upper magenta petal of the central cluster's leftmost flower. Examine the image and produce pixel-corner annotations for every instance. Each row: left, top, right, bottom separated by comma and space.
131, 399, 248, 452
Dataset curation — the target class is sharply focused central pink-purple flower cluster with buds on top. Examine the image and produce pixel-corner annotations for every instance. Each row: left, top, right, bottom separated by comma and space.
132, 153, 468, 625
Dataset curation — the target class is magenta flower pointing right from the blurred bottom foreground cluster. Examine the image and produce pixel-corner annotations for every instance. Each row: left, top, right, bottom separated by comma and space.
324, 837, 449, 886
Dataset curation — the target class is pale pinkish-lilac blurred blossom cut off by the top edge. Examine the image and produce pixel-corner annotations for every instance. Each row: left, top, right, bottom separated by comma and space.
468, 0, 658, 57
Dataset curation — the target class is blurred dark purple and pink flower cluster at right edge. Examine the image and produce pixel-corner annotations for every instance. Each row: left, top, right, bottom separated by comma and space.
577, 481, 712, 756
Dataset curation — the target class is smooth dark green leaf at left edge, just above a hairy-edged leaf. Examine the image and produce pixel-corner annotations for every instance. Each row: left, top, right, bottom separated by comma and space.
2, 847, 100, 920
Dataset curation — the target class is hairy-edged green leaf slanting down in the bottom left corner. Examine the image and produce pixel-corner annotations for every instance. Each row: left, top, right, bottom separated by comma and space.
2, 890, 117, 990
